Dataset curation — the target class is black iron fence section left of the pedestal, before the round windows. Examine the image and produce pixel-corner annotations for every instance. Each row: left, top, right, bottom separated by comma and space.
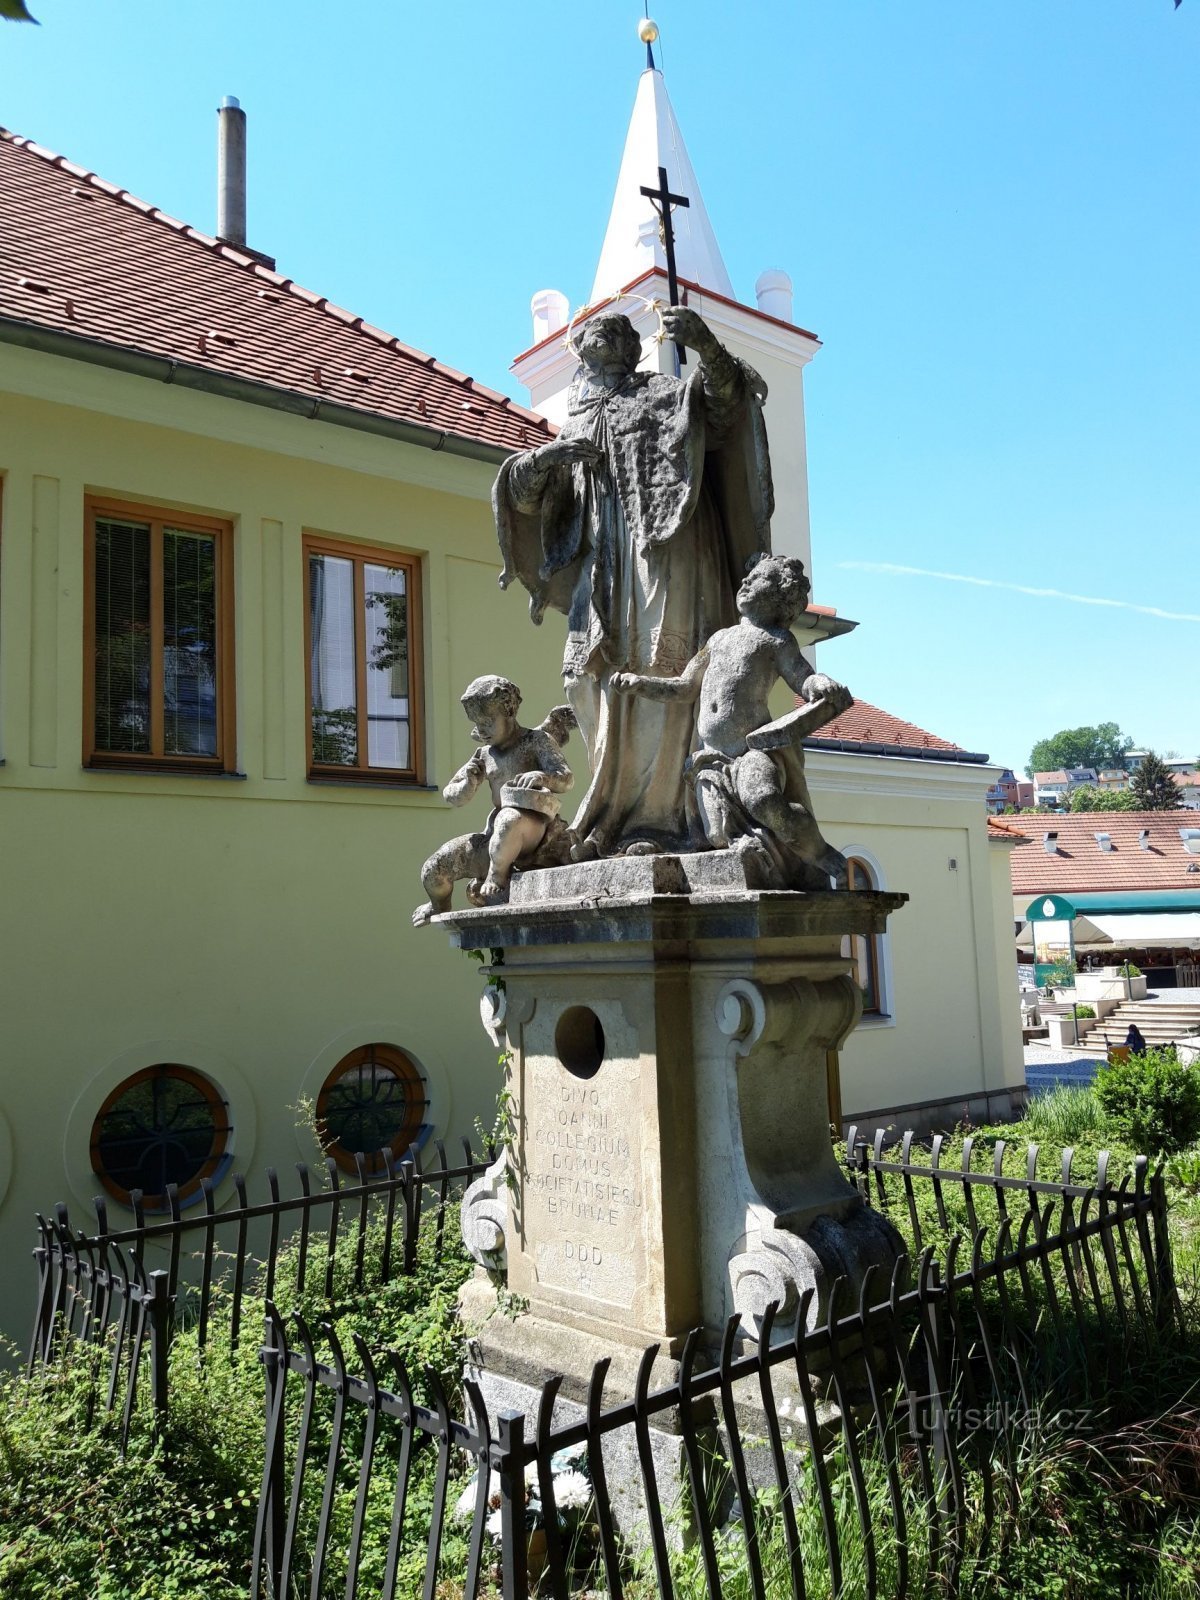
29, 1141, 494, 1446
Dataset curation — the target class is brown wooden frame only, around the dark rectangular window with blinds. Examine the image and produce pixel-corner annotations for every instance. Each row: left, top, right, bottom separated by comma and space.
83, 494, 237, 774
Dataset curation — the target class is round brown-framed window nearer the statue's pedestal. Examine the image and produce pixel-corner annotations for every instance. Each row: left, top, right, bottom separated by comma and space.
317, 1045, 429, 1173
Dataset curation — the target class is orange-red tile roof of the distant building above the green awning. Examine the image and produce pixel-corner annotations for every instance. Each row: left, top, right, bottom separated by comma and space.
1013, 811, 1200, 896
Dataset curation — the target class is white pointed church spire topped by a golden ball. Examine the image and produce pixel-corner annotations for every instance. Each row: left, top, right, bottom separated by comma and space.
590, 19, 734, 306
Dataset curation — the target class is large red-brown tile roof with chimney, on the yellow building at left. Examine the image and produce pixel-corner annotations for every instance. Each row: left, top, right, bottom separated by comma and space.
0, 128, 552, 450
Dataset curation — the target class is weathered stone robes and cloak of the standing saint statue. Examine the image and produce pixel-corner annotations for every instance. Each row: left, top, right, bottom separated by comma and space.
493, 349, 773, 856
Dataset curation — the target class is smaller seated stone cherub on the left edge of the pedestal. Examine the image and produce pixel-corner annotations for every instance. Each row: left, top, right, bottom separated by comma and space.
413, 675, 574, 928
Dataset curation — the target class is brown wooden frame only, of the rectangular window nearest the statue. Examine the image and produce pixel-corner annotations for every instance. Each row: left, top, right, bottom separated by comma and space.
301, 530, 426, 789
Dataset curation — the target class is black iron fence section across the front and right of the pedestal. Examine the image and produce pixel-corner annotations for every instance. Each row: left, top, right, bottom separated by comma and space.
251, 1134, 1178, 1600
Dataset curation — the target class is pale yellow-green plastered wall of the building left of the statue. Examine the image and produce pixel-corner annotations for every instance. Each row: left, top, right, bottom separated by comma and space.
0, 371, 569, 1338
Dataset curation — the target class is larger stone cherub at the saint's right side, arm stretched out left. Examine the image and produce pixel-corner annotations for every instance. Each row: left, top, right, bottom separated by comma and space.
611, 555, 853, 888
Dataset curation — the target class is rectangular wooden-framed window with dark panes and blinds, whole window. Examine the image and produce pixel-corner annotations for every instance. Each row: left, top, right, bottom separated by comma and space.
83, 499, 237, 771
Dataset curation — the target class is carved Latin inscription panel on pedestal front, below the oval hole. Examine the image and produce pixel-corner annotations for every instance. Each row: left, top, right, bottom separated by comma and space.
523, 1059, 642, 1306
